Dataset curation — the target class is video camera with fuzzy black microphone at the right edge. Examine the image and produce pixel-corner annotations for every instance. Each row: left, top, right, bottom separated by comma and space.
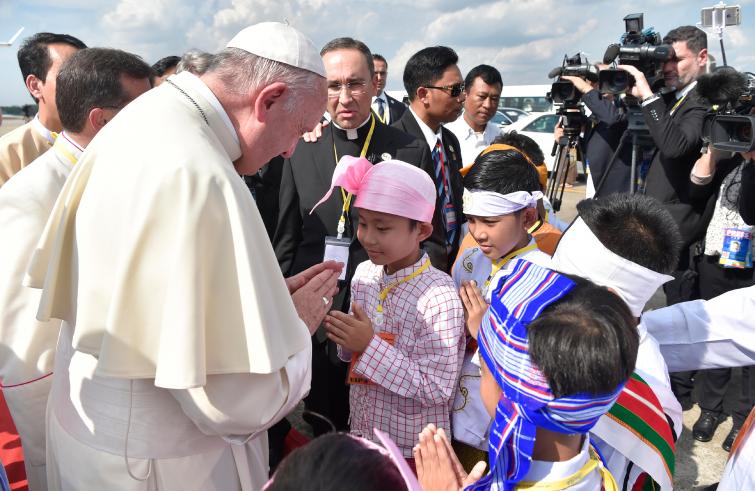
697, 66, 755, 152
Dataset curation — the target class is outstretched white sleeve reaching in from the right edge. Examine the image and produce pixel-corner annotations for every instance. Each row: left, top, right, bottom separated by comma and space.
642, 286, 755, 372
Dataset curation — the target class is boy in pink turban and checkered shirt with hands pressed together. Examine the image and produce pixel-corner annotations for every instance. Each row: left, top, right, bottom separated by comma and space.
318, 156, 464, 465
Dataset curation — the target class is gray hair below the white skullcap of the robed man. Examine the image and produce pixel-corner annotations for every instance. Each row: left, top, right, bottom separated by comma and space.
206, 48, 325, 112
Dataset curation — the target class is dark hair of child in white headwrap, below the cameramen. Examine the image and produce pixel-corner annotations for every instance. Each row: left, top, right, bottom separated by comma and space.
577, 193, 682, 274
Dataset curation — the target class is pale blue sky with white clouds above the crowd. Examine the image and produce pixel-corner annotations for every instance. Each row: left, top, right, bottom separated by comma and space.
0, 0, 755, 105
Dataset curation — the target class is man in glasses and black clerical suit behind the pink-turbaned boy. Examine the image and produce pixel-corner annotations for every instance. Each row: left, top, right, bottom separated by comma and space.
273, 38, 440, 435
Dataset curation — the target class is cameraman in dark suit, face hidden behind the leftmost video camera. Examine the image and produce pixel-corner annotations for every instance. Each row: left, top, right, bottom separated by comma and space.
561, 70, 632, 197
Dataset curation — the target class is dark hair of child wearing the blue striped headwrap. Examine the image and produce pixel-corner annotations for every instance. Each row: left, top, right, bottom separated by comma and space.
527, 276, 640, 398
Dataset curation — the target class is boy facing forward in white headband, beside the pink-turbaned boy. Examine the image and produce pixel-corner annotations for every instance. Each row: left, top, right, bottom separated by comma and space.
451, 145, 550, 471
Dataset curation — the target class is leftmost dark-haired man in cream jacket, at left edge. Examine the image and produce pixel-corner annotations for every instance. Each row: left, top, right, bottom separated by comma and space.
0, 32, 86, 186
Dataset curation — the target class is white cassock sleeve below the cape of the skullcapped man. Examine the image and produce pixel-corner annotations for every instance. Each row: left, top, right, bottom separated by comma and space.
170, 347, 312, 444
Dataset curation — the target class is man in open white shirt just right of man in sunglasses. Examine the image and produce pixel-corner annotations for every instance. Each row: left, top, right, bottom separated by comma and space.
446, 65, 503, 166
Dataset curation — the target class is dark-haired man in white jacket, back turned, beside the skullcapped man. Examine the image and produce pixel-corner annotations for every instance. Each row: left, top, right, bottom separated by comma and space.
0, 48, 152, 491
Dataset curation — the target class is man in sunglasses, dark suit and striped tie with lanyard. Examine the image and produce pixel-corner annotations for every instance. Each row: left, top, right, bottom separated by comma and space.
393, 46, 466, 271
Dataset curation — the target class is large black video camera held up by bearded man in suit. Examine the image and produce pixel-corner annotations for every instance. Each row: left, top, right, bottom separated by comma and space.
599, 14, 675, 94
